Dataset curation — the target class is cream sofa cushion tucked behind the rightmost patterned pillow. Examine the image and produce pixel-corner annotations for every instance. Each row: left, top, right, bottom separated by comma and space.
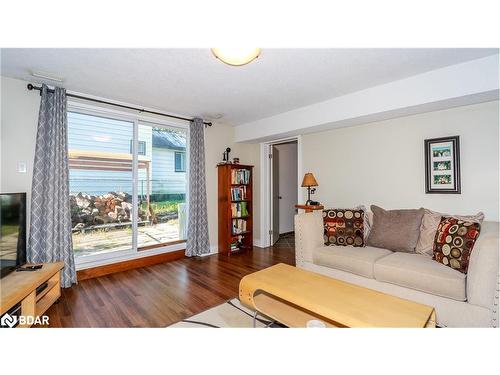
414, 209, 484, 257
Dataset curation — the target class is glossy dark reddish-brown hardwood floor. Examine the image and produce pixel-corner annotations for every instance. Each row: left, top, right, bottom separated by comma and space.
42, 246, 295, 327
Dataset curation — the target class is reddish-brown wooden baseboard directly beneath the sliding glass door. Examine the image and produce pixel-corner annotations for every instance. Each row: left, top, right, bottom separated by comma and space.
76, 250, 185, 281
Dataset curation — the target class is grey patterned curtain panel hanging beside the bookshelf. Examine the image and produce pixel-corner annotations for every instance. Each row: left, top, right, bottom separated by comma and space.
186, 118, 210, 257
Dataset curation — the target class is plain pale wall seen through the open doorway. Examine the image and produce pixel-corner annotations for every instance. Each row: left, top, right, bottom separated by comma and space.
274, 142, 297, 234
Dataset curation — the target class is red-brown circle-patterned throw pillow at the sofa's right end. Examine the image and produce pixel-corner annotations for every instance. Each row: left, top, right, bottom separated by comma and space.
432, 216, 481, 274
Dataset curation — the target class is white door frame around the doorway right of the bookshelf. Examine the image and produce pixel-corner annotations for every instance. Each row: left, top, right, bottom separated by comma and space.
260, 135, 305, 247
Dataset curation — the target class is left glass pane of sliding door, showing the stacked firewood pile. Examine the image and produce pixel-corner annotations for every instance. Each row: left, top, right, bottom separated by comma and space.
68, 112, 134, 256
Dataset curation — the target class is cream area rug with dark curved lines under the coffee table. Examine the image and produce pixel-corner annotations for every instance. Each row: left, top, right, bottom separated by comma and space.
168, 298, 283, 328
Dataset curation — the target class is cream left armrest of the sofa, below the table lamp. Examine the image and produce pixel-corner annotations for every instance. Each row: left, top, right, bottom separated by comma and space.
295, 211, 324, 267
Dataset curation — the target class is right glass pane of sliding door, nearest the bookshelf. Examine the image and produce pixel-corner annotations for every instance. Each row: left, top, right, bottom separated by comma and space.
137, 124, 187, 249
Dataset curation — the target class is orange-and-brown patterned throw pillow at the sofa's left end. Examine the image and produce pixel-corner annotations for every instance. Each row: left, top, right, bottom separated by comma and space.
323, 209, 365, 247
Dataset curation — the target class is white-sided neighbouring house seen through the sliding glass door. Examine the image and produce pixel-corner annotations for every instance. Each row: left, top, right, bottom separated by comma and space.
68, 112, 186, 200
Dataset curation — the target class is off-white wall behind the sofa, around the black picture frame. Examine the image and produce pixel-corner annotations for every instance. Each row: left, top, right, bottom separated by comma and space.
302, 101, 499, 220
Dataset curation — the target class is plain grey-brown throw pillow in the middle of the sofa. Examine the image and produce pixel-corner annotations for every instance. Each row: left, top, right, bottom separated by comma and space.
366, 205, 424, 253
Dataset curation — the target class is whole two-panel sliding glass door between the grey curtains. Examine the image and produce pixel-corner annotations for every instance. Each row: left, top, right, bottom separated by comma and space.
68, 111, 187, 264
